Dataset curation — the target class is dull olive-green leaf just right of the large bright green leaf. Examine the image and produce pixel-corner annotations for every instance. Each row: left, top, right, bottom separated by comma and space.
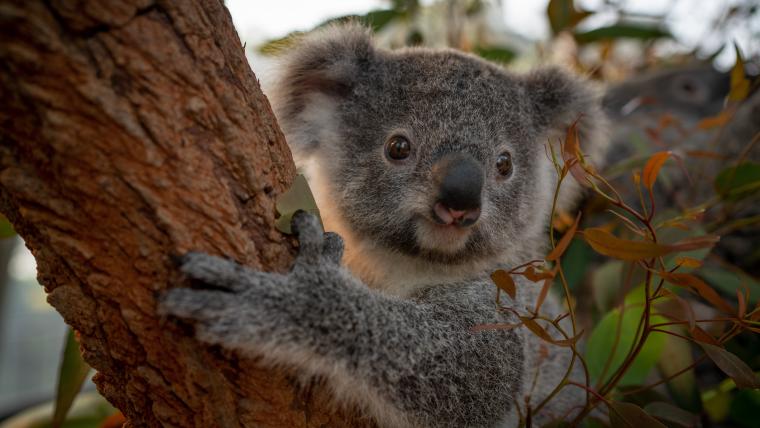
650, 336, 702, 416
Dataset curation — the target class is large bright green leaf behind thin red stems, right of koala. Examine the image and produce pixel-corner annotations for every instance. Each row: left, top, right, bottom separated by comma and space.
586, 287, 666, 386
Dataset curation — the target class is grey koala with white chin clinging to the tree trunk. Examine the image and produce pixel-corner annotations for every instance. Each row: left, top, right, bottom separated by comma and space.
161, 25, 606, 427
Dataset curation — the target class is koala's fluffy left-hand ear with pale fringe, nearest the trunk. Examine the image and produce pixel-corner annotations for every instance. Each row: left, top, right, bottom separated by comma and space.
270, 24, 376, 155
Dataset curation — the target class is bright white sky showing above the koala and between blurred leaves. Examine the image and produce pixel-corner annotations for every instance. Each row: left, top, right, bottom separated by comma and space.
226, 0, 760, 73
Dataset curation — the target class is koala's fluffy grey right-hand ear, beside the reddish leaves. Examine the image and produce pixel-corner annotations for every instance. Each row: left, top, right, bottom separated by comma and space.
525, 67, 609, 210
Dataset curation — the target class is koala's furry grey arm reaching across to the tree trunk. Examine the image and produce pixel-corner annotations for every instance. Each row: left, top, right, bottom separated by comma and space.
161, 215, 524, 427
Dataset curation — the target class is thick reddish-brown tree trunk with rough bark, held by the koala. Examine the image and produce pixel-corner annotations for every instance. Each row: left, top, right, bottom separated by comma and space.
0, 0, 366, 427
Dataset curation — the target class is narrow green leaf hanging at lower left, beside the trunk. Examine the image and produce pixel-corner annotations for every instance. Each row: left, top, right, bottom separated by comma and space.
52, 328, 90, 428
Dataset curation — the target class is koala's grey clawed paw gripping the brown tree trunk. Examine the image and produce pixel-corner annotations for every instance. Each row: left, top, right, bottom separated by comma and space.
159, 213, 343, 351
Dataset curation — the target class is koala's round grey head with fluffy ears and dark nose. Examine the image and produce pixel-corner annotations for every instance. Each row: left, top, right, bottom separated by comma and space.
273, 26, 602, 274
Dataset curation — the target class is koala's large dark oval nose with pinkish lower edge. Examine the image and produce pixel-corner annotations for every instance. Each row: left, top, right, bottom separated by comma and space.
433, 154, 483, 226
